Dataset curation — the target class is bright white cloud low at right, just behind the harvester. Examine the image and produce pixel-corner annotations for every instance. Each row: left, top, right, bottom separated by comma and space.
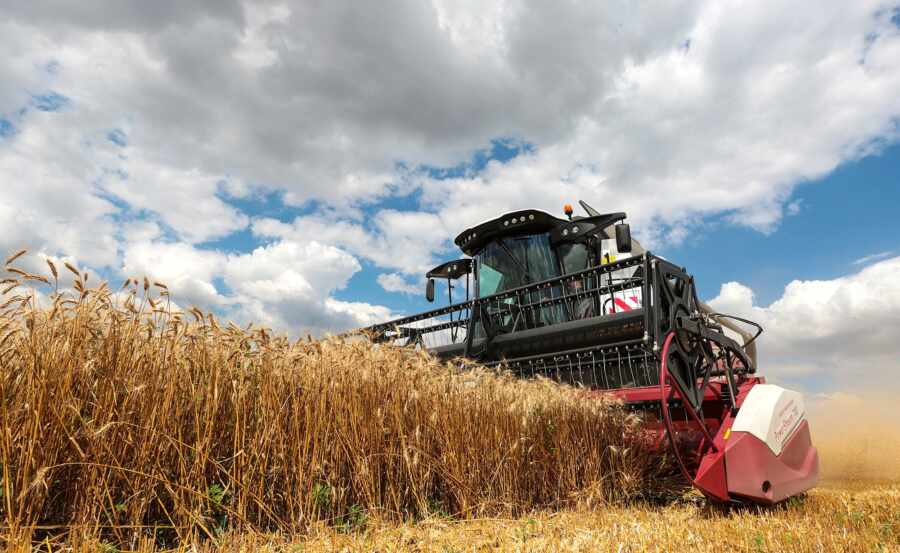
709, 257, 900, 389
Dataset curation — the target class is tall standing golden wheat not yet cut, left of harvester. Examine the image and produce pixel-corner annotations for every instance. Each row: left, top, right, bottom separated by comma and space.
0, 251, 673, 547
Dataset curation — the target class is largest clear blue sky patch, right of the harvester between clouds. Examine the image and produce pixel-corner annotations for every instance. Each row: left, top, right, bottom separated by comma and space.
660, 142, 900, 305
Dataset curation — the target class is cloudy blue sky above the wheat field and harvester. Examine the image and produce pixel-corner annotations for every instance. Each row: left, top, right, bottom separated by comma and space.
0, 0, 900, 392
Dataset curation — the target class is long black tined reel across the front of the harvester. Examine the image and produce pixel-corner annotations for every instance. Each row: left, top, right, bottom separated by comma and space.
358, 255, 659, 389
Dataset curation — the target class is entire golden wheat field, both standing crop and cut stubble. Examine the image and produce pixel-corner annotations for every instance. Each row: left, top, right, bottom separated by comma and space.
0, 252, 900, 552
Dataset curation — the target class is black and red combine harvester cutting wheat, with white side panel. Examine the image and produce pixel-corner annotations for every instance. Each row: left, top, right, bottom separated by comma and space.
356, 202, 819, 504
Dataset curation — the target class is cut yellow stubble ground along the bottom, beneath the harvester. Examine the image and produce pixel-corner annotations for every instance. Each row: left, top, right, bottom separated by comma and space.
10, 481, 900, 553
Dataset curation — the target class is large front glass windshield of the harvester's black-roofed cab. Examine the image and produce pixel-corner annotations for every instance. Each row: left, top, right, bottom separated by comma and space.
475, 234, 559, 297
